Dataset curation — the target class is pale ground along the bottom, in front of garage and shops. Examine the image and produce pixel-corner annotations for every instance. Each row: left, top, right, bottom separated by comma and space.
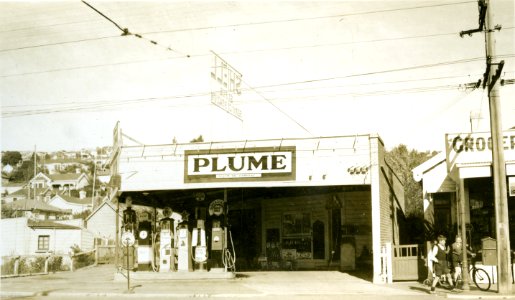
0, 265, 515, 299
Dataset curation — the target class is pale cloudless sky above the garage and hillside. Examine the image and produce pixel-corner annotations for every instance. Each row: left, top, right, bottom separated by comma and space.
0, 0, 515, 151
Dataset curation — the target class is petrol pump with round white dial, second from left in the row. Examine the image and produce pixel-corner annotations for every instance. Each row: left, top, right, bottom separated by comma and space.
137, 212, 153, 271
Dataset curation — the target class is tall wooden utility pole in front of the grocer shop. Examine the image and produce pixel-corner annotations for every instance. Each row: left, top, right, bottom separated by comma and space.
485, 1, 512, 294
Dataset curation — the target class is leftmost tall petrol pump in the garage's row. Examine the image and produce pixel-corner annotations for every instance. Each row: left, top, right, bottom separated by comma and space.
121, 197, 138, 270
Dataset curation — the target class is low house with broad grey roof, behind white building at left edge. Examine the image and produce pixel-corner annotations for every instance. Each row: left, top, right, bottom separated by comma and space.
2, 199, 72, 220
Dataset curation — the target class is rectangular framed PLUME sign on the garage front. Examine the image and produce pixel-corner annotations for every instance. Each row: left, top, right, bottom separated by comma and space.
184, 146, 296, 183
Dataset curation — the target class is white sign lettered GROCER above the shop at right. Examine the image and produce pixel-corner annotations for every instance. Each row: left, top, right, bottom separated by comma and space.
446, 130, 515, 167
